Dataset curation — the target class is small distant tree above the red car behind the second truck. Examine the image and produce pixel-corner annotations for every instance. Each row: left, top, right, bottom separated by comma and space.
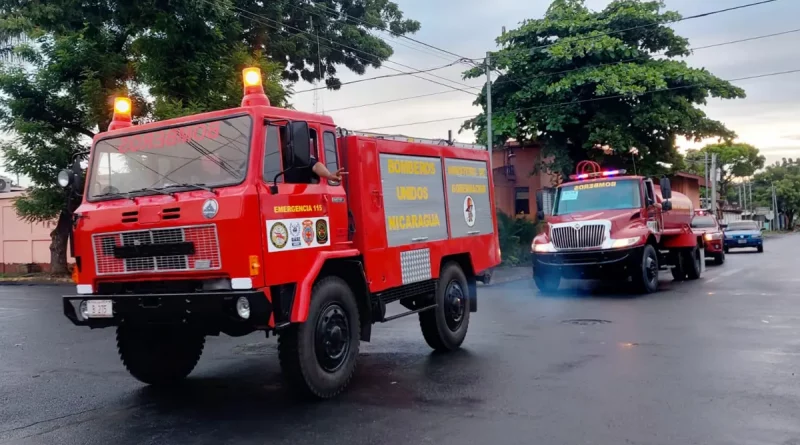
685, 141, 766, 197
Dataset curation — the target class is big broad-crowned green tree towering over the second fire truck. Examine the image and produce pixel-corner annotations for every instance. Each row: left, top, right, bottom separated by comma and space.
464, 0, 745, 177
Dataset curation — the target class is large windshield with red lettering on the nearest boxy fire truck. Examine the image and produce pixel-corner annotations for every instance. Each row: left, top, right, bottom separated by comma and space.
88, 116, 252, 200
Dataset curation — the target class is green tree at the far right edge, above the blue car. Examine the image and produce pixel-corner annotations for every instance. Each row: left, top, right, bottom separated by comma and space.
753, 159, 800, 228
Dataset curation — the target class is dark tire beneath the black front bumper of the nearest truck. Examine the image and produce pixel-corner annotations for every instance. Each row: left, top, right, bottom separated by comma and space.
117, 324, 206, 385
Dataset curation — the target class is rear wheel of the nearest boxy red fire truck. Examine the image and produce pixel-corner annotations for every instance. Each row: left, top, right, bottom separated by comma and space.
419, 263, 470, 352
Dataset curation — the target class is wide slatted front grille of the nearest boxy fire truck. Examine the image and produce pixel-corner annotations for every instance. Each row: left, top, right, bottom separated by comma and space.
92, 225, 222, 275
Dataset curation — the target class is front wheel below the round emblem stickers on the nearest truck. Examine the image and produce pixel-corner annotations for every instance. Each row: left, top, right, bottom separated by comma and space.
278, 277, 361, 399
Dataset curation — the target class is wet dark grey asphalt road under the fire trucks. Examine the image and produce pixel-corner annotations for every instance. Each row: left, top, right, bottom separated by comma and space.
0, 236, 800, 445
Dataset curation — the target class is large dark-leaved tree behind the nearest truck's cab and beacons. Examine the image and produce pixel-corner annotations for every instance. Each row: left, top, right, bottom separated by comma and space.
0, 0, 419, 272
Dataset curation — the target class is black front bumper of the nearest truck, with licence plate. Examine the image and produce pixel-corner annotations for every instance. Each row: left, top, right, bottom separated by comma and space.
62, 290, 272, 331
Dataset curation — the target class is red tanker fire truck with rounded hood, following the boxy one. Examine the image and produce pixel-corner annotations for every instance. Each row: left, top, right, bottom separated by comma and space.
531, 161, 704, 293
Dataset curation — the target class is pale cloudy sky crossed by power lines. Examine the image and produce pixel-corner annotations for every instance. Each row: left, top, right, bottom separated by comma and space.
293, 0, 800, 163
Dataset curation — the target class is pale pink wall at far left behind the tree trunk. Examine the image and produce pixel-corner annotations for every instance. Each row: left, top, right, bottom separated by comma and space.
0, 192, 72, 273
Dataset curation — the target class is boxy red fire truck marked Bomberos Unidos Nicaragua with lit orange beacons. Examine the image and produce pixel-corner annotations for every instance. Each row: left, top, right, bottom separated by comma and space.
59, 69, 500, 398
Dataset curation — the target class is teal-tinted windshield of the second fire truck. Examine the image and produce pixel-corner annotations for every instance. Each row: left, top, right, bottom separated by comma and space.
553, 179, 642, 215
